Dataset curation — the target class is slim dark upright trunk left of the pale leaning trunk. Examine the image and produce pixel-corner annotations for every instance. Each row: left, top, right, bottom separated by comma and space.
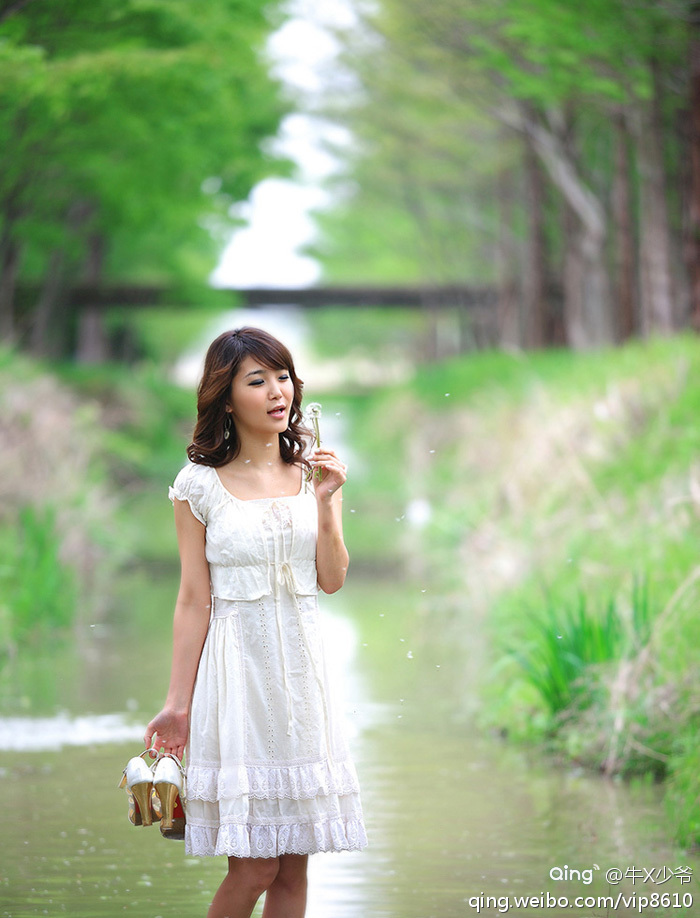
523, 141, 548, 348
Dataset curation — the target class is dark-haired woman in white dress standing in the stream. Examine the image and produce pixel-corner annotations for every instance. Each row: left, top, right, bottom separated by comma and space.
145, 328, 367, 918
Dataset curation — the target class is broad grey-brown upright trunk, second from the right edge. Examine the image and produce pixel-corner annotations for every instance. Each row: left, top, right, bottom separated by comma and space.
637, 62, 675, 334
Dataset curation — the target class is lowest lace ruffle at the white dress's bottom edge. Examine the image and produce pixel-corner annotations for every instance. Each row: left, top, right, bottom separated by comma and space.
185, 816, 367, 857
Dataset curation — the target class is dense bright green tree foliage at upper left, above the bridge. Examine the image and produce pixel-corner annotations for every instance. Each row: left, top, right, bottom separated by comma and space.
0, 0, 285, 351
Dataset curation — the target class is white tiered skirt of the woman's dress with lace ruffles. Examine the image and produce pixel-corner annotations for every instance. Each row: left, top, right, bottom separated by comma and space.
185, 596, 367, 857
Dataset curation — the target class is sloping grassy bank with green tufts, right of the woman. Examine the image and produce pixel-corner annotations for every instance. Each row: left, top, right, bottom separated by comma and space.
334, 337, 700, 843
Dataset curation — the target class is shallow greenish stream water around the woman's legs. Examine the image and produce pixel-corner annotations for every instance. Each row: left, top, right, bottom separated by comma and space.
0, 572, 700, 918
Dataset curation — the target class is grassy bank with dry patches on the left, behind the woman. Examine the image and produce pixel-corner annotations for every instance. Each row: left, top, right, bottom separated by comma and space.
0, 351, 194, 662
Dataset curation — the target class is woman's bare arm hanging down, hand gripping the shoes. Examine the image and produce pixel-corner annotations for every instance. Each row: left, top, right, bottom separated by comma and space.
144, 500, 211, 759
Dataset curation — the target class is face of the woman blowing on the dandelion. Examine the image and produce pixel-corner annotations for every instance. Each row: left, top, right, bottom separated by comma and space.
229, 356, 294, 438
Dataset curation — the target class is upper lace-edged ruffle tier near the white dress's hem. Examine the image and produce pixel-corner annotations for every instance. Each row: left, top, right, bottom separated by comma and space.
187, 762, 360, 803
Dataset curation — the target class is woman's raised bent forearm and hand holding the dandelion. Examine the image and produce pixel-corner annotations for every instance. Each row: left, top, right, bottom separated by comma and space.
310, 449, 349, 593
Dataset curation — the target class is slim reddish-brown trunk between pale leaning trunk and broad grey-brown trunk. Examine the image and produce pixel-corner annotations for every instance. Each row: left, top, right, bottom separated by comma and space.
612, 114, 637, 341
